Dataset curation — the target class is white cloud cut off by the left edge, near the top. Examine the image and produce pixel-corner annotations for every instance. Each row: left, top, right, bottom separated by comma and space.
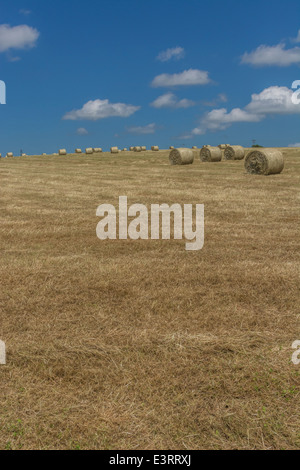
0, 24, 40, 52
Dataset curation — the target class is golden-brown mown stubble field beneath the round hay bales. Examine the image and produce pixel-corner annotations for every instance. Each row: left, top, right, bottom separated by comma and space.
0, 149, 300, 450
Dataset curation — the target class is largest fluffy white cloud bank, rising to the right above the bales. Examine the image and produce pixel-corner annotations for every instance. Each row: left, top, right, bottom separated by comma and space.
192, 86, 300, 135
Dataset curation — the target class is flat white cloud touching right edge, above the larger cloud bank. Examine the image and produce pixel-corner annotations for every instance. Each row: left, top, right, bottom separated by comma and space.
241, 44, 300, 67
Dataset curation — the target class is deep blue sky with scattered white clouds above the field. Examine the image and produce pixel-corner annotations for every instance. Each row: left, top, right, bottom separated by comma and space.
0, 0, 300, 155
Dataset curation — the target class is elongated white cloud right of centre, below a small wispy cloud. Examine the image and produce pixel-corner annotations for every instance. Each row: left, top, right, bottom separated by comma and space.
152, 69, 211, 88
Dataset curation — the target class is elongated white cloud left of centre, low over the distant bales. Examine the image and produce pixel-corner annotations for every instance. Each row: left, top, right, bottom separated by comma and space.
63, 100, 141, 121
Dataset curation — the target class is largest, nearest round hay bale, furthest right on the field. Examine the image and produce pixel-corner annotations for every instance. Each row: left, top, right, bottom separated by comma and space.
245, 148, 284, 175
